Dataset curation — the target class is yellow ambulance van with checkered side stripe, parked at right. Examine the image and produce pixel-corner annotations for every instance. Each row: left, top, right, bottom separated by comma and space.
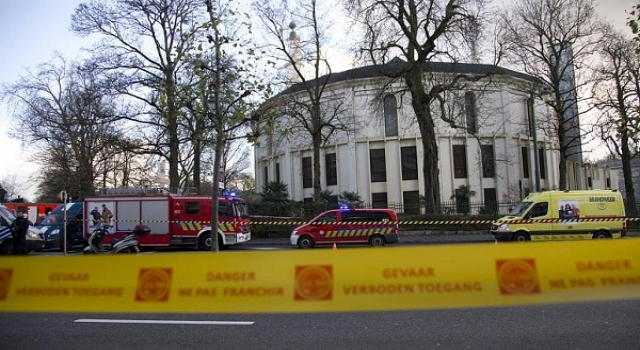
491, 190, 627, 241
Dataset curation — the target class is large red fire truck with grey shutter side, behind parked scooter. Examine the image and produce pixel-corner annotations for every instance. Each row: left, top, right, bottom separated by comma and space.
83, 188, 251, 250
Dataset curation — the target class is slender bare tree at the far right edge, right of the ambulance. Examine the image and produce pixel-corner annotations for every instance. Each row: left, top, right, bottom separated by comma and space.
592, 29, 640, 216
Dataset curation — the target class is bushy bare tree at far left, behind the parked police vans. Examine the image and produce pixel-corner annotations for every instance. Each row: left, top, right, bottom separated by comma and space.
2, 56, 125, 201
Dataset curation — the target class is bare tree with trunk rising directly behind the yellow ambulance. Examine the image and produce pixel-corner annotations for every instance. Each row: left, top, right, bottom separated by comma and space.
501, 0, 603, 190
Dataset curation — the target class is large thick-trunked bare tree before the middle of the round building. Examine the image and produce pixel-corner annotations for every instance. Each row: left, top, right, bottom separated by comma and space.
345, 0, 499, 213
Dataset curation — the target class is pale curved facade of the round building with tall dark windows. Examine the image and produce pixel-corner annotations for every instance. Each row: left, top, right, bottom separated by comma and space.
254, 61, 606, 212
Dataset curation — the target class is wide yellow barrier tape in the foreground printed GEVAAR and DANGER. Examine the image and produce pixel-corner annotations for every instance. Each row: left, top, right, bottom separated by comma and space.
0, 239, 640, 313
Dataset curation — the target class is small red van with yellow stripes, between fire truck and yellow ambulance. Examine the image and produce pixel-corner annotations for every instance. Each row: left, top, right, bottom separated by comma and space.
290, 208, 398, 248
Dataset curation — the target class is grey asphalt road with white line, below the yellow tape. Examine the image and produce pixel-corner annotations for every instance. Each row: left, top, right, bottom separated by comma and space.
0, 301, 640, 350
